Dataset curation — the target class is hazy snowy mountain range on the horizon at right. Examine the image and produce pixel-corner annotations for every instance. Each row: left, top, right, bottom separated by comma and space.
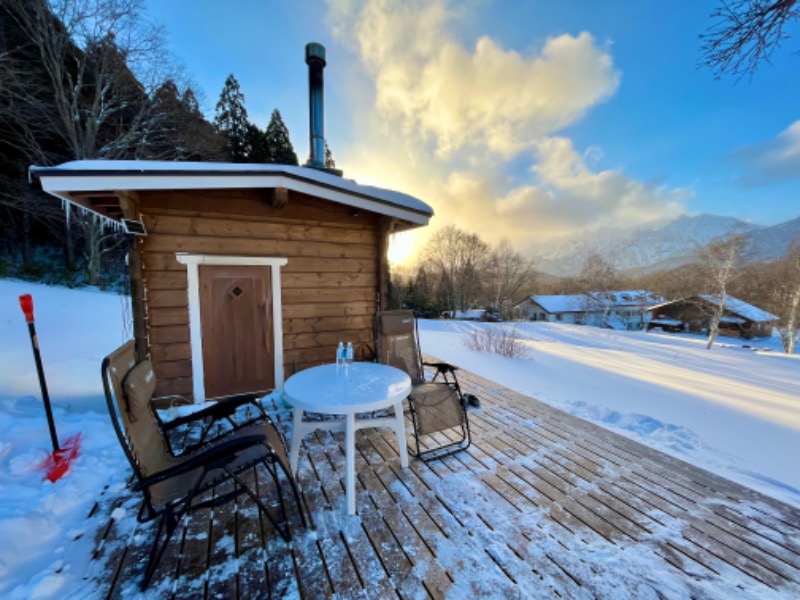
529, 215, 800, 277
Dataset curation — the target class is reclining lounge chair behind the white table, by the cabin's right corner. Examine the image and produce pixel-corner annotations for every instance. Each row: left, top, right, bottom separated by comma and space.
378, 310, 471, 461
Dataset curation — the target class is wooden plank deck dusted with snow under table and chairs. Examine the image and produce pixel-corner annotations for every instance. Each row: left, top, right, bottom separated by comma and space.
86, 364, 800, 599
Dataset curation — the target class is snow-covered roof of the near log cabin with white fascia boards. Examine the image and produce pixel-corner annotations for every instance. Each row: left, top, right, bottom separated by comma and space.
29, 160, 433, 228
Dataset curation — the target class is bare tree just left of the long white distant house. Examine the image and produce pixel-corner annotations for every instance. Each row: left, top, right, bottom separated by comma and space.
484, 238, 534, 320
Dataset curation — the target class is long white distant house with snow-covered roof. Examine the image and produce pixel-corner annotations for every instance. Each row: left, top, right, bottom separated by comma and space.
514, 290, 664, 330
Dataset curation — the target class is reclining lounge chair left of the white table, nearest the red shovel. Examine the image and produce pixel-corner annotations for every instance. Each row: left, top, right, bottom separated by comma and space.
101, 342, 306, 589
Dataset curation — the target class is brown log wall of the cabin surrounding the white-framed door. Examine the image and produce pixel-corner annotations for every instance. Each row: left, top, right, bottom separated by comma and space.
138, 190, 385, 396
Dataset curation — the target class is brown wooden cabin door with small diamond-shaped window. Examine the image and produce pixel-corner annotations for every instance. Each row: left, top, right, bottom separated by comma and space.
199, 265, 275, 398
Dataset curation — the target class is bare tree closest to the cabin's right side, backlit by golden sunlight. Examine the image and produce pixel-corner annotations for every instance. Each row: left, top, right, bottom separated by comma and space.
423, 225, 489, 312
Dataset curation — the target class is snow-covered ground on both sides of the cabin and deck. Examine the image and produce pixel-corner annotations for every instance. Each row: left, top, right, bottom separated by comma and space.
0, 280, 800, 599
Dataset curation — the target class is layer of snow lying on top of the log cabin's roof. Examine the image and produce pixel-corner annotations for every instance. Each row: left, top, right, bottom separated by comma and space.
30, 160, 433, 216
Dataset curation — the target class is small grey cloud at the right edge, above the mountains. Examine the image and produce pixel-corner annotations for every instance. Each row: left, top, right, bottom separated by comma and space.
734, 120, 800, 186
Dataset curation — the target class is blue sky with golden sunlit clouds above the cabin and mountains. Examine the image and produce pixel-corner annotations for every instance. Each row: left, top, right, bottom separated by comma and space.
146, 0, 800, 261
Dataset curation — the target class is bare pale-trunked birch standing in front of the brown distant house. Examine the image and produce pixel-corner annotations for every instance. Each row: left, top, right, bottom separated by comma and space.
700, 235, 745, 349
